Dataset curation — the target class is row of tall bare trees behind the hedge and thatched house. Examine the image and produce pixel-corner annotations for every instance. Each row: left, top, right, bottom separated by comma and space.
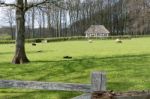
1, 0, 150, 38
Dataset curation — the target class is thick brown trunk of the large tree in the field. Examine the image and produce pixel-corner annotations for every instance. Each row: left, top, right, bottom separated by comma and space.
12, 0, 29, 64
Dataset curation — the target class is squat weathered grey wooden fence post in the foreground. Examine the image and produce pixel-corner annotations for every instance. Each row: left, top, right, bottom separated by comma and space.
91, 72, 106, 92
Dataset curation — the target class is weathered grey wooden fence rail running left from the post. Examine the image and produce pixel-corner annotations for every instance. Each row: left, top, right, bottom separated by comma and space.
0, 80, 91, 92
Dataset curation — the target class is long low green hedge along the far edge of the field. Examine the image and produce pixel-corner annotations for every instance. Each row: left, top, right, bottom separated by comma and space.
0, 35, 150, 44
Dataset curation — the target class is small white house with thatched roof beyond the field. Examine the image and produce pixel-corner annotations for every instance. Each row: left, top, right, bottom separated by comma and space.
85, 25, 110, 37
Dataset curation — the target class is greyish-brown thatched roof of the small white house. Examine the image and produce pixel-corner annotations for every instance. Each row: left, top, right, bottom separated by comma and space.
85, 25, 110, 34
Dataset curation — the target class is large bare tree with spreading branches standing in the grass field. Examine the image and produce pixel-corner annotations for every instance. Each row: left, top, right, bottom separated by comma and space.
0, 0, 63, 64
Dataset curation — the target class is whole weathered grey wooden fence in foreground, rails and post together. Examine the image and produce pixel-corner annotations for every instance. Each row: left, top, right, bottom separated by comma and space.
0, 72, 150, 99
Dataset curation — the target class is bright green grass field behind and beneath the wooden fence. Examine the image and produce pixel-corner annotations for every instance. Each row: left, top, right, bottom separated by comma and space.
0, 38, 150, 99
